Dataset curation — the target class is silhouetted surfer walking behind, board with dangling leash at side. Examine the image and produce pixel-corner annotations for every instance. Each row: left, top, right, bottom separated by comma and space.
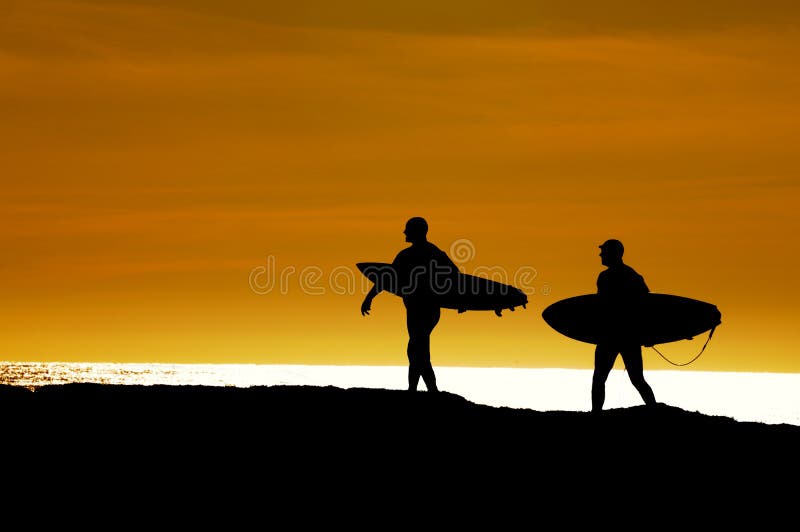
592, 239, 656, 413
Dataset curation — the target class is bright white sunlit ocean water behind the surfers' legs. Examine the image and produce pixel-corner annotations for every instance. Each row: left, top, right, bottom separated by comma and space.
0, 362, 800, 426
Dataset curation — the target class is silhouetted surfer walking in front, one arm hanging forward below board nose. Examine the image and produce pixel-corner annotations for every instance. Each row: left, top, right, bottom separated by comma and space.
361, 217, 458, 392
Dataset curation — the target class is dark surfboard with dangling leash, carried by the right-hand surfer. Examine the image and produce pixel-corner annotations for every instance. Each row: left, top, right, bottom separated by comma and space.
542, 293, 722, 347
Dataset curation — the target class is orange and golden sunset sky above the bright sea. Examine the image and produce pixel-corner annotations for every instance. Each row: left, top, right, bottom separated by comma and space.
0, 0, 800, 373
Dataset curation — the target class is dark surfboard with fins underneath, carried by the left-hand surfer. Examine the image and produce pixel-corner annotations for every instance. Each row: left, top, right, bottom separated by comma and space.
356, 262, 528, 316
